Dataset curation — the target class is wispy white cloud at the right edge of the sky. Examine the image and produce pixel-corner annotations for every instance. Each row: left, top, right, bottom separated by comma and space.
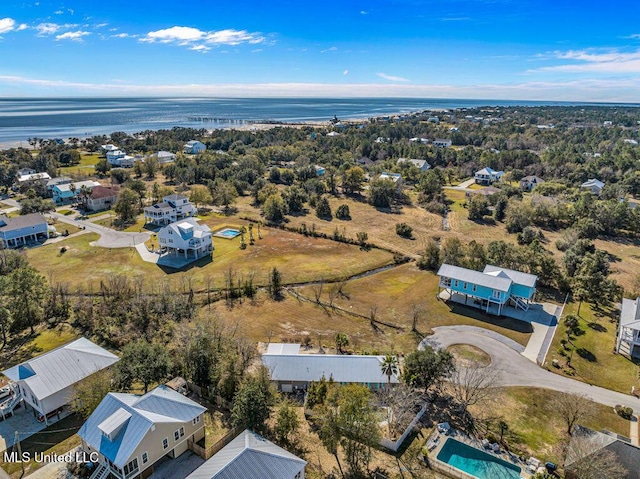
527, 49, 640, 74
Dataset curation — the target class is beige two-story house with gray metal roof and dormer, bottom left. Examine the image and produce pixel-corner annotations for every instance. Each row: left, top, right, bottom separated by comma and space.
78, 386, 206, 479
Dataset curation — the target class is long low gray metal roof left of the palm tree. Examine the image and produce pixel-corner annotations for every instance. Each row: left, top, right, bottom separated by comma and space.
262, 354, 399, 384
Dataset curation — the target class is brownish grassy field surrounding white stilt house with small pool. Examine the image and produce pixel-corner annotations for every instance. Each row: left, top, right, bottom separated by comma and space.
27, 218, 393, 289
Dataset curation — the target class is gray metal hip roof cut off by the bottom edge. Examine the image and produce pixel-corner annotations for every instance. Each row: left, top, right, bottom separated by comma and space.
186, 429, 307, 479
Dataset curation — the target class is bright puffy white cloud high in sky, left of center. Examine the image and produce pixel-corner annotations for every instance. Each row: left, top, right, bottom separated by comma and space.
140, 26, 266, 51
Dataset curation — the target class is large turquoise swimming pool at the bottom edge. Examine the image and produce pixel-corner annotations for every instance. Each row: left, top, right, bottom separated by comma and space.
438, 438, 521, 479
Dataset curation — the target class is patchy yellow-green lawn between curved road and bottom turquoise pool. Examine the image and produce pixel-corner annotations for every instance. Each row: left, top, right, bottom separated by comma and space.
476, 387, 629, 464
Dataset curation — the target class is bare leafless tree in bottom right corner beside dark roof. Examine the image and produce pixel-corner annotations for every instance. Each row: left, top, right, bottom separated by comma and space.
565, 435, 628, 479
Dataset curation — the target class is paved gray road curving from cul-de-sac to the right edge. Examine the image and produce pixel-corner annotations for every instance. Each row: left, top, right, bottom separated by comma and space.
419, 326, 640, 414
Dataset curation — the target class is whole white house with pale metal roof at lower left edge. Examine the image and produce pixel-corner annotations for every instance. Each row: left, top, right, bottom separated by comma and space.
3, 338, 118, 424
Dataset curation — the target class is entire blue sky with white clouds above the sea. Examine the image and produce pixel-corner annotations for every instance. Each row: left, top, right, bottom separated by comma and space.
0, 0, 640, 102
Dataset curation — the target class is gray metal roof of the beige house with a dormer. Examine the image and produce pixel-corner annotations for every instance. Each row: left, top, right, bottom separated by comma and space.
78, 386, 206, 467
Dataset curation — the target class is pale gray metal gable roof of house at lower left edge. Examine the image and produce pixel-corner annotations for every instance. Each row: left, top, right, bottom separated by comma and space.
3, 338, 118, 400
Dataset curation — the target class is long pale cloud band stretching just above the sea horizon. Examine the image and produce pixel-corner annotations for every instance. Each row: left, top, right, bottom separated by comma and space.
0, 76, 640, 103
